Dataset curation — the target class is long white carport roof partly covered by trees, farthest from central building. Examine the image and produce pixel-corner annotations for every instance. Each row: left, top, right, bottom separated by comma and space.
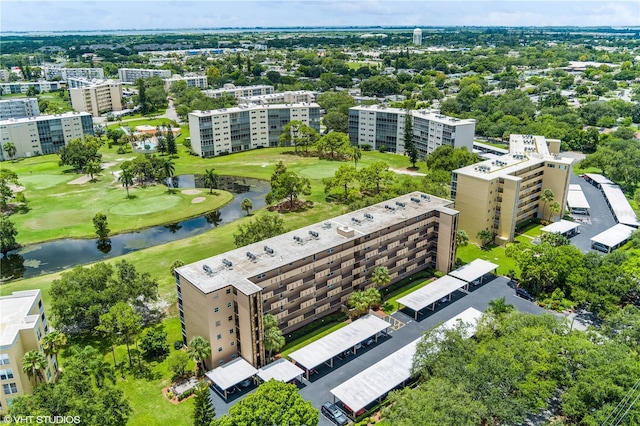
331, 308, 482, 415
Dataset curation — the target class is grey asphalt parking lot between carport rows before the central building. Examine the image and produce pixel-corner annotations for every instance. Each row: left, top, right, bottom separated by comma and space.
206, 277, 557, 426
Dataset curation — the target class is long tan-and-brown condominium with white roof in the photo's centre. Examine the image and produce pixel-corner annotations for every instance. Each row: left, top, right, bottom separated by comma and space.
175, 192, 458, 366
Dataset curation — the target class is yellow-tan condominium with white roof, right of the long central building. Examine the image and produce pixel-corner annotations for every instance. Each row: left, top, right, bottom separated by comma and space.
451, 135, 573, 244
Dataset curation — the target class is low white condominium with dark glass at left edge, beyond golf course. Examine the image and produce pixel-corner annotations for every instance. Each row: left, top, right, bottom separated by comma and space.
0, 112, 93, 159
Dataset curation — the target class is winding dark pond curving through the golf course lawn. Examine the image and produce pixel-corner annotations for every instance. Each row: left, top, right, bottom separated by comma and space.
0, 175, 271, 282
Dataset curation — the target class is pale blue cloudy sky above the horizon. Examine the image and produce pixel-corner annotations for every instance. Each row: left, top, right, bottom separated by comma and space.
0, 0, 640, 32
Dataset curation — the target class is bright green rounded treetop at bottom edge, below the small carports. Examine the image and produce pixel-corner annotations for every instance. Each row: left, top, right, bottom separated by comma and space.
211, 380, 320, 426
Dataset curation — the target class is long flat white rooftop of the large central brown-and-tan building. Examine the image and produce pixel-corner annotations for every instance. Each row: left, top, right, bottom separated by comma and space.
176, 192, 456, 295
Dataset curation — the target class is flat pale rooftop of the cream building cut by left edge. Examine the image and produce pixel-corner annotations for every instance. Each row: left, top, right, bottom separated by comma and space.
0, 290, 40, 346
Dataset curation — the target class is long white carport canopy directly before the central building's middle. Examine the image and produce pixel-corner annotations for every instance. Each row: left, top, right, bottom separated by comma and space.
289, 314, 390, 376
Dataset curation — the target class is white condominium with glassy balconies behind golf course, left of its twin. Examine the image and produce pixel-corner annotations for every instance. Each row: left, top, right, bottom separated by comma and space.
189, 103, 320, 157
